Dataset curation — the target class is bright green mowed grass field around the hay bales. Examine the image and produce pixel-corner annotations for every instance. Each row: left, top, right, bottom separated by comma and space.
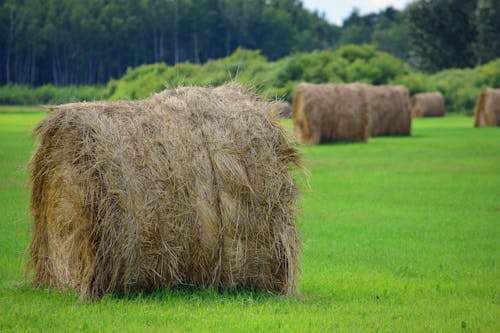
0, 113, 500, 332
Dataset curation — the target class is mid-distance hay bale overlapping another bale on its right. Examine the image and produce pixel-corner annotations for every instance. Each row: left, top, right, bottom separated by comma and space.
292, 83, 368, 145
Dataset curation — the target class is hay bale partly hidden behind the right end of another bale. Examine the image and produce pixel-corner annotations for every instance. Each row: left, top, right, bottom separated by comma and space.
364, 85, 411, 136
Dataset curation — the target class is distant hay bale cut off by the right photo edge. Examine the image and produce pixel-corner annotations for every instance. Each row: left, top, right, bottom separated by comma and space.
474, 88, 500, 127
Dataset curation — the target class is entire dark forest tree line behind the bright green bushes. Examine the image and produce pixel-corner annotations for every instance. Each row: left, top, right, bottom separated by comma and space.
0, 0, 500, 86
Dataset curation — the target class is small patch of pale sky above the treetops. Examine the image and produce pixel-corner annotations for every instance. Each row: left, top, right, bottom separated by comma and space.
302, 0, 411, 25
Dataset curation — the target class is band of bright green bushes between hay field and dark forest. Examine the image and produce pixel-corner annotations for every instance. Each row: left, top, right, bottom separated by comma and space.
0, 45, 500, 114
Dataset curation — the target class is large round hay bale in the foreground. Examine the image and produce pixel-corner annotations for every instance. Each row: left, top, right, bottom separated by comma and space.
29, 85, 300, 299
